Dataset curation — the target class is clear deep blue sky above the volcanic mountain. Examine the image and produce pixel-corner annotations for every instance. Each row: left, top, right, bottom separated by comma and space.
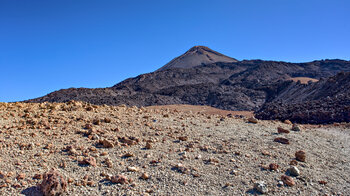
0, 0, 350, 102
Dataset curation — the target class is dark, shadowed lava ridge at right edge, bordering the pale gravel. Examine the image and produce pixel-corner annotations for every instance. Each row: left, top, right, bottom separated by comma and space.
256, 72, 350, 124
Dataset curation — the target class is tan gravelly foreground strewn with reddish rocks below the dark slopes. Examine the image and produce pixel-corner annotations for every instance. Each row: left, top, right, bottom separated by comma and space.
0, 101, 350, 195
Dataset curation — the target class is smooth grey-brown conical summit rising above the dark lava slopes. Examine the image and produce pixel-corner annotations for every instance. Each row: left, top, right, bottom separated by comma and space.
157, 46, 237, 71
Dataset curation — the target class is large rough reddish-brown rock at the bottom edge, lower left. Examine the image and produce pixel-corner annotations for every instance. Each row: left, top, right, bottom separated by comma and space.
38, 169, 67, 196
